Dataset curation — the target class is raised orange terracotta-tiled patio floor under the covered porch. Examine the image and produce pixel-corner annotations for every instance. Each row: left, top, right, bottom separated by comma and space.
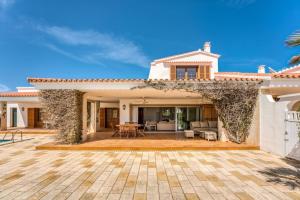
36, 131, 259, 151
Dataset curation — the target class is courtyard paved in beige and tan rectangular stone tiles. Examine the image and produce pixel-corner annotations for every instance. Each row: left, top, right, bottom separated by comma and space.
0, 135, 300, 200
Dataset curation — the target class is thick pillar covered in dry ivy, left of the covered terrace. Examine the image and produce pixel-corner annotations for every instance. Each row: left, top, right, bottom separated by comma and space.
39, 89, 84, 144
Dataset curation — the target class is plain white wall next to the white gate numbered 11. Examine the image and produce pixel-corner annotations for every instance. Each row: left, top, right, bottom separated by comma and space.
260, 95, 288, 156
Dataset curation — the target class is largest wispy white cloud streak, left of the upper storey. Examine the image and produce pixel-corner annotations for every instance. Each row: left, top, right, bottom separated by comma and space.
38, 26, 149, 67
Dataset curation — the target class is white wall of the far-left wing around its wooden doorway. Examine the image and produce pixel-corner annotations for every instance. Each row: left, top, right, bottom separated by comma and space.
7, 103, 41, 128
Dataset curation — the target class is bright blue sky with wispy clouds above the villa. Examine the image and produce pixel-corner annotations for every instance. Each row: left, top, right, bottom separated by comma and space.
0, 0, 300, 91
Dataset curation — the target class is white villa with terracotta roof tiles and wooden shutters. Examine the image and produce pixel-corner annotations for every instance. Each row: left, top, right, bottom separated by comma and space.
0, 42, 300, 159
